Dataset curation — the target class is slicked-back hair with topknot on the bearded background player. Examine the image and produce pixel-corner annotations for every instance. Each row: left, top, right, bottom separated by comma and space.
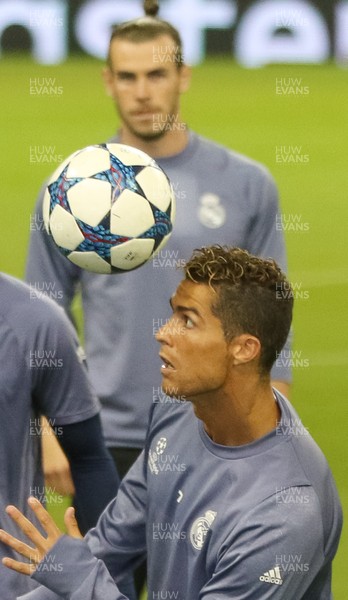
107, 0, 184, 68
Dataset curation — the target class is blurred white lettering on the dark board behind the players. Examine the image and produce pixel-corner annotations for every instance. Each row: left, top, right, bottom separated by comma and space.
0, 0, 348, 67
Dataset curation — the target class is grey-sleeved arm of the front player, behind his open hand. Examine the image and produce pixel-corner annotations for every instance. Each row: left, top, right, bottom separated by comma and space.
20, 452, 147, 600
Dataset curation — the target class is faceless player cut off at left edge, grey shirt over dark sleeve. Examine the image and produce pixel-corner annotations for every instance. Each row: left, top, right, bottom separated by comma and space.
0, 273, 133, 600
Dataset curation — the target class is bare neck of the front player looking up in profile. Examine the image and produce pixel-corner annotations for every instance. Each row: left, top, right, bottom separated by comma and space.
191, 380, 280, 446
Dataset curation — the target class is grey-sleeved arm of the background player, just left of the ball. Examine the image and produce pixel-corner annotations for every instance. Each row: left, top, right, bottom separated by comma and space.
25, 186, 81, 316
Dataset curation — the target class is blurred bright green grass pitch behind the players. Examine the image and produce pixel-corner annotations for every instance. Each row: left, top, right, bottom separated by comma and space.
0, 57, 348, 600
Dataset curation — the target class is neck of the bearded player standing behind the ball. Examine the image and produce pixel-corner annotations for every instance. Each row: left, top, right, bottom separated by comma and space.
119, 123, 189, 159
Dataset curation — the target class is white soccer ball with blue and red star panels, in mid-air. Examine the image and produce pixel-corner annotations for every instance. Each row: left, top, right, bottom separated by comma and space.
43, 144, 175, 274
